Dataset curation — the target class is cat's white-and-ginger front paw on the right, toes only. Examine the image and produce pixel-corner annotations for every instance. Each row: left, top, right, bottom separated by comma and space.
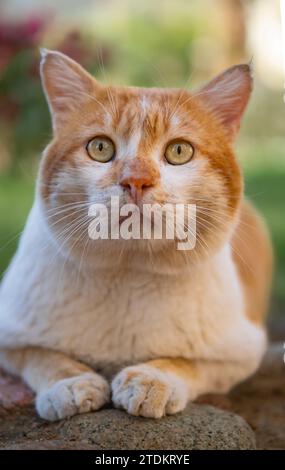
112, 364, 188, 418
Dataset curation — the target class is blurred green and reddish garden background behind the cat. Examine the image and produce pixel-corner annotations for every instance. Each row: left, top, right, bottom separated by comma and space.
0, 0, 285, 317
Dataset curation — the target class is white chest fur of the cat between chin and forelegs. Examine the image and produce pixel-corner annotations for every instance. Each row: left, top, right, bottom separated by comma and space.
0, 204, 265, 372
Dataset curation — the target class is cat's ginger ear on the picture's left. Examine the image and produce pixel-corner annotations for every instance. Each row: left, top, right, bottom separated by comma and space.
40, 49, 100, 131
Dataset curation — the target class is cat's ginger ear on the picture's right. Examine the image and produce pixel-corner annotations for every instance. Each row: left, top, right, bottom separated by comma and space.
196, 64, 252, 139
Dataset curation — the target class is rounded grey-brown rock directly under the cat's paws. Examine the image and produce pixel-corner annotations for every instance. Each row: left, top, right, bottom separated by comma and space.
0, 404, 255, 450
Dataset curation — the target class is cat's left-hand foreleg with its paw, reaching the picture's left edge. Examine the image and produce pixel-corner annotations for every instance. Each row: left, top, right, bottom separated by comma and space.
0, 348, 110, 421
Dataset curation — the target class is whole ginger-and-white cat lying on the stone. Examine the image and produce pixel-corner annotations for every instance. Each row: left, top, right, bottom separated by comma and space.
0, 50, 272, 421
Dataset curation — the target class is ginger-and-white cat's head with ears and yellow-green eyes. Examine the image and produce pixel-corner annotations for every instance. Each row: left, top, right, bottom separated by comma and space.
38, 50, 252, 267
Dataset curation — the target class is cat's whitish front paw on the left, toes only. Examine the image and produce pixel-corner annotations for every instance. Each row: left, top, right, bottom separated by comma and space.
36, 372, 110, 421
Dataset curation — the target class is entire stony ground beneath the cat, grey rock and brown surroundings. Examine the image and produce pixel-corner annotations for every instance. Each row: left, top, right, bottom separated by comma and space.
0, 344, 285, 450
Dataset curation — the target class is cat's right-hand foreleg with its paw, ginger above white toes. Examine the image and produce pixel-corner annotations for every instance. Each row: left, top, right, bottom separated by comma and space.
112, 359, 258, 418
